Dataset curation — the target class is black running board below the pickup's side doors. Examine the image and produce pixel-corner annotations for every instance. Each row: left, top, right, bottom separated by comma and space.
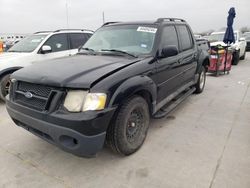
153, 87, 195, 119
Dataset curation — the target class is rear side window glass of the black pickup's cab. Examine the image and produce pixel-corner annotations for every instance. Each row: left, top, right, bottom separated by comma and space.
177, 25, 193, 51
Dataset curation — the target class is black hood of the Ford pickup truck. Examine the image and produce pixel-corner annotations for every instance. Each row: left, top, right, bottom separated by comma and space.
12, 55, 144, 89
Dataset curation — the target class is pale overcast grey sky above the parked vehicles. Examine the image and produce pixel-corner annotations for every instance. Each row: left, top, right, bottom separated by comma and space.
0, 0, 250, 33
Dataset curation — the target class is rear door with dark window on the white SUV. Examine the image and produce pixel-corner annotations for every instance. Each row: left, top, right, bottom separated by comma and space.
68, 33, 90, 55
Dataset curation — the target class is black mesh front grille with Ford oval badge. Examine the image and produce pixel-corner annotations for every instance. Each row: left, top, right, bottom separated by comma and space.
14, 82, 56, 111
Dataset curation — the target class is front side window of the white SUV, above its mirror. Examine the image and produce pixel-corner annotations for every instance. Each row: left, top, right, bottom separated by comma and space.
44, 33, 69, 52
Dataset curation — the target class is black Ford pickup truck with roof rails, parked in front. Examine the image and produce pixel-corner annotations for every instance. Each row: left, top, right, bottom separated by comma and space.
6, 18, 209, 157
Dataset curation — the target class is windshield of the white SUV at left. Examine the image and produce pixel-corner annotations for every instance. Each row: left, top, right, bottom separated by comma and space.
8, 35, 47, 52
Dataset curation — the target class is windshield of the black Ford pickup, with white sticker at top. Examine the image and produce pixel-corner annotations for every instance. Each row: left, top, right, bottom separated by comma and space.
83, 25, 157, 55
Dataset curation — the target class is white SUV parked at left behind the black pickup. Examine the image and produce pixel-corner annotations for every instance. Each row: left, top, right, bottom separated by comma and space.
0, 29, 93, 100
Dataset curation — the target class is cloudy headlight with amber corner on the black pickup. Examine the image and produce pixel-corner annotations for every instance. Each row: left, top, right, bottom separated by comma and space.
64, 90, 107, 112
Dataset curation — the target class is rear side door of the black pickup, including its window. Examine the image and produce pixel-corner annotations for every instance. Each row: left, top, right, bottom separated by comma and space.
176, 25, 198, 85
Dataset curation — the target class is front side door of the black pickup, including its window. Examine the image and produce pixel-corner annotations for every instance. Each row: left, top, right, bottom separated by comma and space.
156, 25, 182, 103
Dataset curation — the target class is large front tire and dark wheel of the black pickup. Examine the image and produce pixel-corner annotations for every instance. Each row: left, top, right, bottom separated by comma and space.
106, 96, 150, 156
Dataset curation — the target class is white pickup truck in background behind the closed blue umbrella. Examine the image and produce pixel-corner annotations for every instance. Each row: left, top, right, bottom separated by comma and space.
209, 31, 247, 65
